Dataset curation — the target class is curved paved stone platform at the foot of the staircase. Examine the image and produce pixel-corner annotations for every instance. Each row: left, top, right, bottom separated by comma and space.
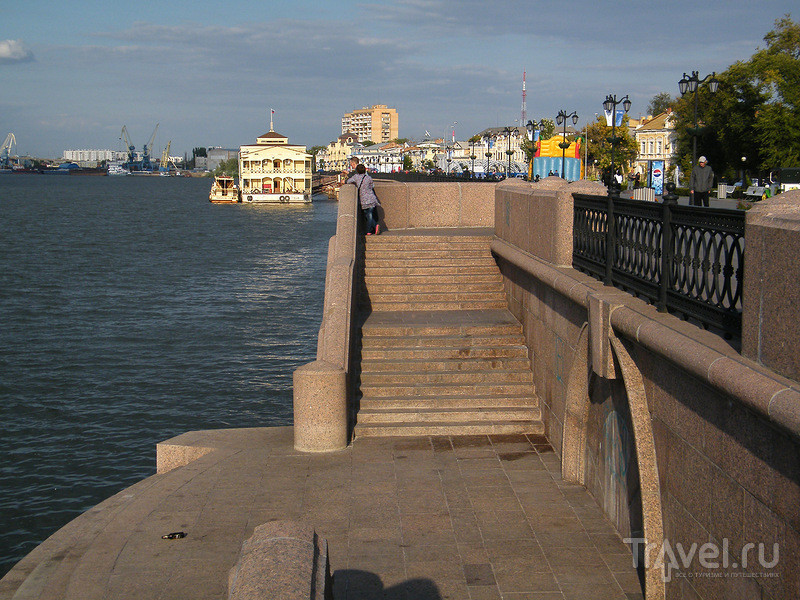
0, 427, 642, 600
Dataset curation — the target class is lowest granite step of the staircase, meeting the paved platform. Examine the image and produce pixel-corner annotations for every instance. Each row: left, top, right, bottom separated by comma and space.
353, 420, 544, 437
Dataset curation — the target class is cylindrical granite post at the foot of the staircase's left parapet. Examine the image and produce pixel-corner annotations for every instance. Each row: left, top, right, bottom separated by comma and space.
293, 360, 347, 452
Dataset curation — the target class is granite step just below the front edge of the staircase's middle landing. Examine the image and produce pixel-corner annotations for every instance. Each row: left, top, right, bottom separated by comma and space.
361, 338, 528, 358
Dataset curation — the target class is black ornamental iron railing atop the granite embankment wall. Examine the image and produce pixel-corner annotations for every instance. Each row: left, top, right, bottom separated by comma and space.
572, 194, 745, 338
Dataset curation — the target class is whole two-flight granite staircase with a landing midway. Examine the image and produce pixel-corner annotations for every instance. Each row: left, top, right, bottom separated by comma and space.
355, 232, 544, 437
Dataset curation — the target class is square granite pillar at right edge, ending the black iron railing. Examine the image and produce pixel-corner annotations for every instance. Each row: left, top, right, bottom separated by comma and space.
742, 190, 800, 380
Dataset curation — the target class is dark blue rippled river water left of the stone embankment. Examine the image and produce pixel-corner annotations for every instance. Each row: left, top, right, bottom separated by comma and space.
0, 175, 337, 576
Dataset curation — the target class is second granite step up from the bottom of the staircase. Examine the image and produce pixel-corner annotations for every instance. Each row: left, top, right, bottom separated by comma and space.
358, 406, 541, 425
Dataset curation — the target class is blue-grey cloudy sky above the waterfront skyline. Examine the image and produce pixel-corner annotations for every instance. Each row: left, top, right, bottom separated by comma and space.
0, 0, 800, 158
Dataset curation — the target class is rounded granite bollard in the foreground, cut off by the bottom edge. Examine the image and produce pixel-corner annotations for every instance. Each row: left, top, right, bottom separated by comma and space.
228, 521, 333, 600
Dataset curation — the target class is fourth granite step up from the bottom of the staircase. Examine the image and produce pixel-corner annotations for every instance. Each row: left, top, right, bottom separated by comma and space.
361, 384, 536, 399
